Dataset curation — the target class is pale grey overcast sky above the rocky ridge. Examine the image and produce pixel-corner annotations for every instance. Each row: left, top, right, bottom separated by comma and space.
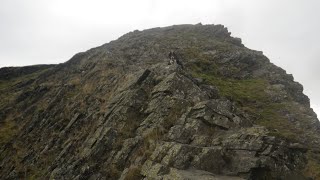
0, 0, 320, 115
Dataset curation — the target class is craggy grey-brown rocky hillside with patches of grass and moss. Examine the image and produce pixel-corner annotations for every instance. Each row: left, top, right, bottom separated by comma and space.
0, 25, 320, 180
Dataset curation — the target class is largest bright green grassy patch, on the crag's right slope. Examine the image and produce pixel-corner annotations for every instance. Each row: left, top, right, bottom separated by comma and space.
188, 58, 302, 141
